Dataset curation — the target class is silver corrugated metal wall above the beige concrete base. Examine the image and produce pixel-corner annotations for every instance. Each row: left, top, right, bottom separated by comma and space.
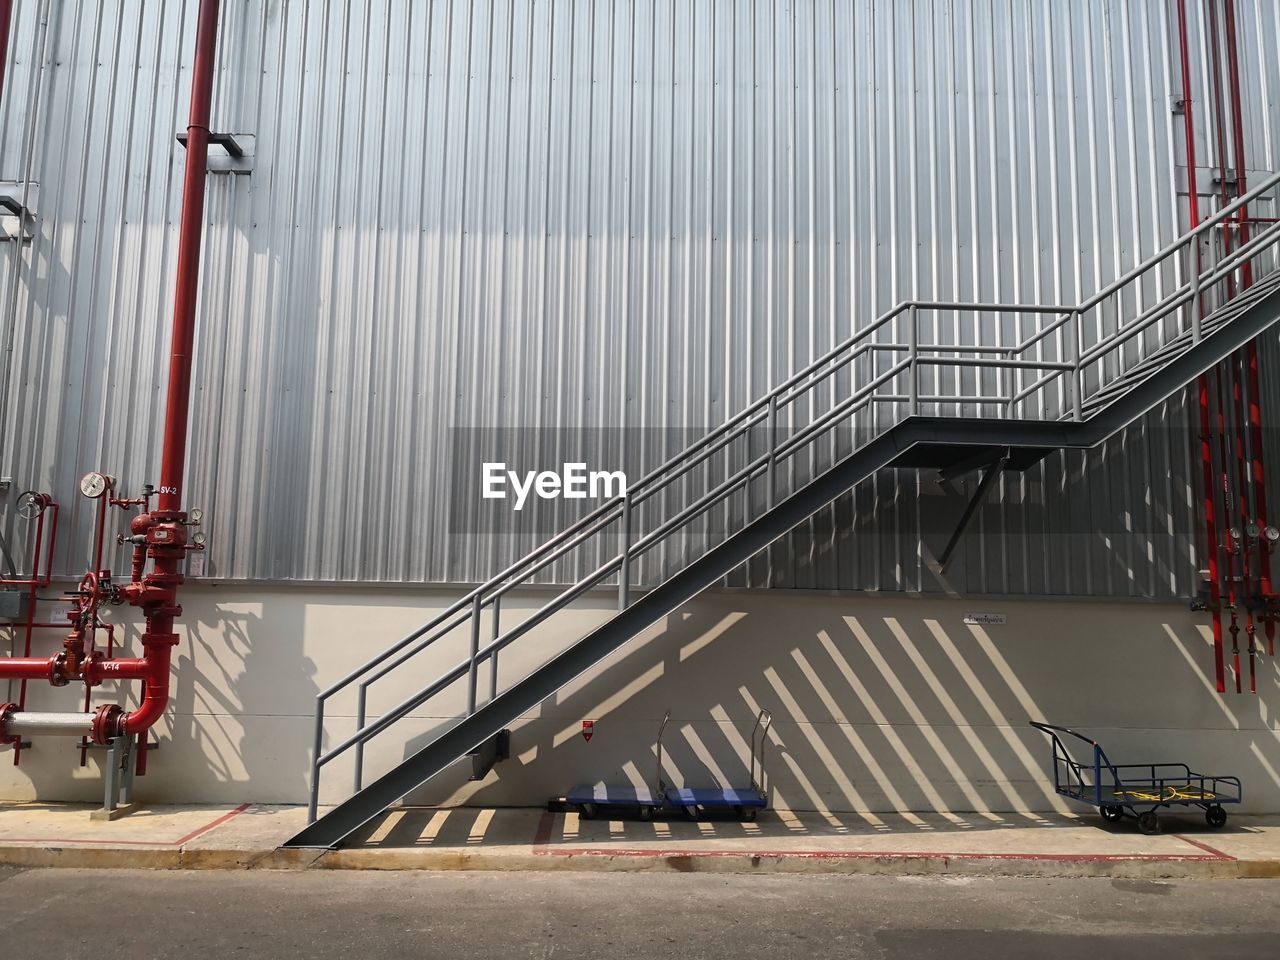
0, 0, 1280, 598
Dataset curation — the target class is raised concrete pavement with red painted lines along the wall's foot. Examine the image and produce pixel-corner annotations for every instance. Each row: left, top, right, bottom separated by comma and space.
0, 804, 1280, 878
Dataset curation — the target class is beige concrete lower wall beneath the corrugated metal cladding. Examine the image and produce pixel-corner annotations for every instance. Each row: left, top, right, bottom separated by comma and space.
0, 585, 1280, 812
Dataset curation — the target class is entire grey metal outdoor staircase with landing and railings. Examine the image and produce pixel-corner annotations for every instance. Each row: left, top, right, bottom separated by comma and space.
285, 174, 1280, 847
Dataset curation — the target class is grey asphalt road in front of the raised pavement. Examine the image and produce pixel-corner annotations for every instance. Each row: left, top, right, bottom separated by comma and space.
0, 870, 1280, 960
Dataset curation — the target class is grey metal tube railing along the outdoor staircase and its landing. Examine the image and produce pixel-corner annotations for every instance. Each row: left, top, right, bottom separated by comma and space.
308, 168, 1280, 822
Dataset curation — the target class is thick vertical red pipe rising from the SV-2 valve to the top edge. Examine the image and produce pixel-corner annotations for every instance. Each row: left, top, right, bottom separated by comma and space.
157, 0, 218, 513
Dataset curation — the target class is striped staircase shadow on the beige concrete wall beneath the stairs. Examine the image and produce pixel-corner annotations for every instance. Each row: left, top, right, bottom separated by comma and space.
404, 593, 1280, 817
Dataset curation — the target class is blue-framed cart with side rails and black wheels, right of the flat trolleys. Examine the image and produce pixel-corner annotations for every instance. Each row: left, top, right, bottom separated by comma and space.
1032, 721, 1242, 833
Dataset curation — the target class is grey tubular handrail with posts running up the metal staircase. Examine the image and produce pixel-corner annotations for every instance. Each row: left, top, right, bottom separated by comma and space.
310, 173, 1280, 819
